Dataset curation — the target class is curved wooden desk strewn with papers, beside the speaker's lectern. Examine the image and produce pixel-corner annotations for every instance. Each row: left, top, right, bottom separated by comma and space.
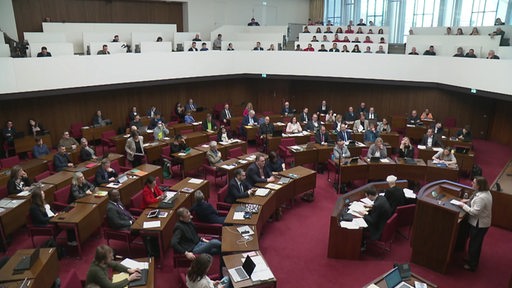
327, 180, 407, 260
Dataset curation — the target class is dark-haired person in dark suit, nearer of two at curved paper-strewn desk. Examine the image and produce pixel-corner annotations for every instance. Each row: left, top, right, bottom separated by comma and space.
363, 187, 392, 240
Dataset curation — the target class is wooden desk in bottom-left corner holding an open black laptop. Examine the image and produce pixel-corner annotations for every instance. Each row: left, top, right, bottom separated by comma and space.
0, 248, 60, 288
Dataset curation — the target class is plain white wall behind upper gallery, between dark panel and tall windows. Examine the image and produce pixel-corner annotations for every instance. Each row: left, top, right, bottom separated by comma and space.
184, 0, 309, 40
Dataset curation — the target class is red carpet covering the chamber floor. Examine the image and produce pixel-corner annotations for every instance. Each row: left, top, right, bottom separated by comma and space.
2, 140, 512, 288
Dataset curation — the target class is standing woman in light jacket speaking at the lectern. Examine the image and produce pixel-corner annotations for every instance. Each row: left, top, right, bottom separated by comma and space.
459, 176, 492, 271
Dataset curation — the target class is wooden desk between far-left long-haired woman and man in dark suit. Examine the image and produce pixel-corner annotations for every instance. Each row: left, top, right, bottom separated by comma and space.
50, 203, 103, 257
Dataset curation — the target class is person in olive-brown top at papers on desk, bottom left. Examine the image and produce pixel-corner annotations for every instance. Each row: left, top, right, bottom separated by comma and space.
85, 245, 141, 287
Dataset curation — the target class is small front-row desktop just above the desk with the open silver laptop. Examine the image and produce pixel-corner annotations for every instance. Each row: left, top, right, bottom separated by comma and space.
221, 225, 260, 254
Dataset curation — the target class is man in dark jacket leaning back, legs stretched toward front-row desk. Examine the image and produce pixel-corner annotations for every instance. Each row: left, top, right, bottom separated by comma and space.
171, 207, 221, 260
